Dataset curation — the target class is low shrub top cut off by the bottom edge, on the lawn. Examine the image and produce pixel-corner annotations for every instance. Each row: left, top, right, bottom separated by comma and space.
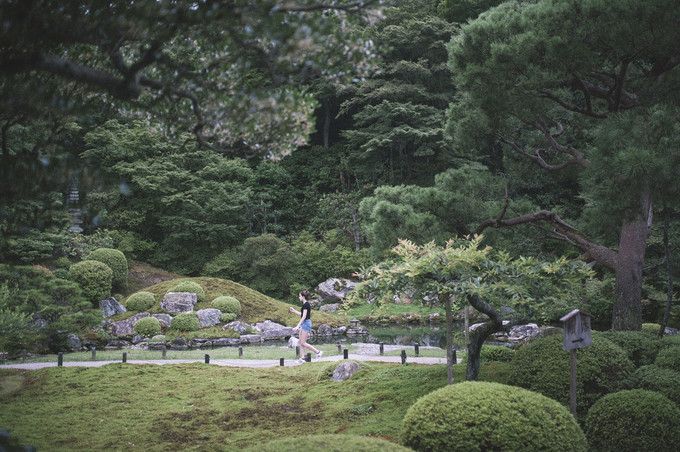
245, 435, 410, 452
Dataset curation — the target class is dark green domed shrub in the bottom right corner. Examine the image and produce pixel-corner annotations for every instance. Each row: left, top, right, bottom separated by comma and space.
585, 389, 680, 452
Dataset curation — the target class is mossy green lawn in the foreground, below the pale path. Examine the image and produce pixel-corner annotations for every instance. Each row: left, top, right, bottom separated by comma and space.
0, 363, 505, 451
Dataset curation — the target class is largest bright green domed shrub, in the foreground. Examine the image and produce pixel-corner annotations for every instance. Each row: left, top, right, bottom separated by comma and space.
400, 381, 588, 452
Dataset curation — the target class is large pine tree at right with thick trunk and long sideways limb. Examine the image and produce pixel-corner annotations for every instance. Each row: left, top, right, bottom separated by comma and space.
449, 0, 680, 329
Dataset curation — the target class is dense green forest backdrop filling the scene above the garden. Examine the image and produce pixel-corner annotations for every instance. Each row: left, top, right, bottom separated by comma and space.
0, 0, 680, 354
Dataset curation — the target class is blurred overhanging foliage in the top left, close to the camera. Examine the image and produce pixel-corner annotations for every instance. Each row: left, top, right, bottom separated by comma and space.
0, 0, 381, 157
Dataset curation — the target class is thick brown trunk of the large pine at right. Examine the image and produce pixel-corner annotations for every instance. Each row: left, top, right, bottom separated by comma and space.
612, 192, 651, 331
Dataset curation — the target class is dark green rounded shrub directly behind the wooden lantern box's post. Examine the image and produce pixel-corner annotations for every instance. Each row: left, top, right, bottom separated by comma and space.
508, 332, 634, 415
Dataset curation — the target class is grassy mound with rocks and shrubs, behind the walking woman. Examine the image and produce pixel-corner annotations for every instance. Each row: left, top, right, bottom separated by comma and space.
117, 277, 348, 327
